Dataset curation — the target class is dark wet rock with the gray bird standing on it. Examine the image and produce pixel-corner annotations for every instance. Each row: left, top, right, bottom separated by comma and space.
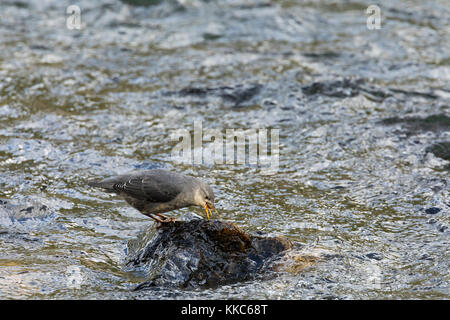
126, 220, 292, 290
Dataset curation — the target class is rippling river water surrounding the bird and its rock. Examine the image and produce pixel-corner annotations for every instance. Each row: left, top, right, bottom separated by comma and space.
0, 0, 450, 299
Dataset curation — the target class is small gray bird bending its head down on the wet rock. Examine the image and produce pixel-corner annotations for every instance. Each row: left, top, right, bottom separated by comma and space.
88, 169, 216, 223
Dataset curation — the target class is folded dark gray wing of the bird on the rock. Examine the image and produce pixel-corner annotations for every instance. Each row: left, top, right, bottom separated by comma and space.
113, 172, 183, 202
